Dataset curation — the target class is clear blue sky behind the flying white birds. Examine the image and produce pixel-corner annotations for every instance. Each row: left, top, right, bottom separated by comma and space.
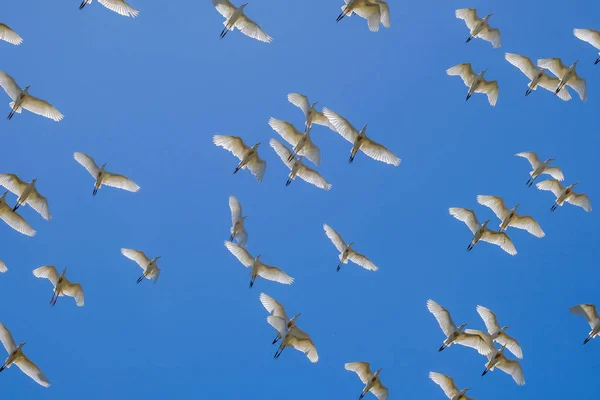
0, 0, 600, 400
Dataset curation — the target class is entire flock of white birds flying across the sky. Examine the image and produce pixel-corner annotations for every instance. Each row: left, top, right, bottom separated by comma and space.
0, 0, 600, 400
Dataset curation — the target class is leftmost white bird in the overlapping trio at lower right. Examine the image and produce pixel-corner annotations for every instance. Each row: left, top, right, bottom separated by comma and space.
427, 299, 491, 355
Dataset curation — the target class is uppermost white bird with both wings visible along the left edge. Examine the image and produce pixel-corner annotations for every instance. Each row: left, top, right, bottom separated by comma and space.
0, 71, 64, 122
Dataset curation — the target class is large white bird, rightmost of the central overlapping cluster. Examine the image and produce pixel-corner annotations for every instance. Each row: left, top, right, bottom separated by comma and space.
323, 108, 400, 167
